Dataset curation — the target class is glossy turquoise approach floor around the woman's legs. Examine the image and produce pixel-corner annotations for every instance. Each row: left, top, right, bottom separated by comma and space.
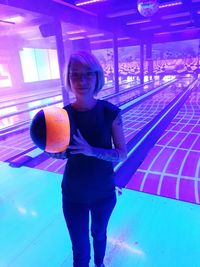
0, 162, 200, 267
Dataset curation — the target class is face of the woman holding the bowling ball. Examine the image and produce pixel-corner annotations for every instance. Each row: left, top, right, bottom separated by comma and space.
69, 61, 96, 97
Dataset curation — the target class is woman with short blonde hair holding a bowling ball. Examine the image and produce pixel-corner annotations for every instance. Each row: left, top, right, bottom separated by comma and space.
50, 52, 127, 267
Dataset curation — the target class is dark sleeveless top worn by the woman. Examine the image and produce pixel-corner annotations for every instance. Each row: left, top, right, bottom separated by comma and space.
62, 100, 120, 203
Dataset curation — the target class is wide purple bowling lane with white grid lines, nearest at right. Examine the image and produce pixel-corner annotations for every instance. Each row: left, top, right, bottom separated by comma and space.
127, 86, 200, 204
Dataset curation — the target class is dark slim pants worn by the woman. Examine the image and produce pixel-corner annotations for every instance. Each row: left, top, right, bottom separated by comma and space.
63, 195, 116, 267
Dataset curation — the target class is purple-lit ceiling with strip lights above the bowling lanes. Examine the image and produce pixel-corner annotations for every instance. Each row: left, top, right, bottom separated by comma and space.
0, 0, 200, 50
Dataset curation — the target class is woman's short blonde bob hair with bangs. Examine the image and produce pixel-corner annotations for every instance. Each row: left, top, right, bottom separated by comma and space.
64, 51, 104, 95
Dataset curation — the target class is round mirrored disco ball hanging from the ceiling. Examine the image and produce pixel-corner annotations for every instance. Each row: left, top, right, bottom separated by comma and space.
137, 0, 159, 17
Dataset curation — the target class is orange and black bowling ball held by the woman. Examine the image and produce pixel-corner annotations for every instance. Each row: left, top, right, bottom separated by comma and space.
30, 107, 70, 153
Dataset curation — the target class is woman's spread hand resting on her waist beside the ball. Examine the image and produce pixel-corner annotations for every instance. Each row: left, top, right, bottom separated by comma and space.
68, 130, 92, 156
